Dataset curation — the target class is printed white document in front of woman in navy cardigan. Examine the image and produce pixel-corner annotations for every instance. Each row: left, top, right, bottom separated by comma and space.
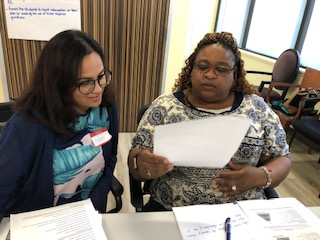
10, 199, 107, 240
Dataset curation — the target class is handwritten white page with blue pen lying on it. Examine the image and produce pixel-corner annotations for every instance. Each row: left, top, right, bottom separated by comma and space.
172, 203, 254, 240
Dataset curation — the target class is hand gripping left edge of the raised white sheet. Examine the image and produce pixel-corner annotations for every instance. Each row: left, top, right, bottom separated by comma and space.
128, 148, 173, 181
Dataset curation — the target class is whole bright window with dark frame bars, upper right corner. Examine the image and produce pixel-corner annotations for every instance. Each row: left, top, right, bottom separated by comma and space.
215, 0, 320, 69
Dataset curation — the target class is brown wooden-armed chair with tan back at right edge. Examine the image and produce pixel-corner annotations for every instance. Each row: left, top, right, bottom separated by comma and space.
266, 68, 320, 131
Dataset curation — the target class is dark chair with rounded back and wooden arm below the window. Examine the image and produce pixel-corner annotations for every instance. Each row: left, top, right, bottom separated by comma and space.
247, 49, 300, 102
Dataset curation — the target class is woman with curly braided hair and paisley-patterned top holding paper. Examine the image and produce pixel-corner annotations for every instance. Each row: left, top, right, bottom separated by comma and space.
128, 32, 291, 211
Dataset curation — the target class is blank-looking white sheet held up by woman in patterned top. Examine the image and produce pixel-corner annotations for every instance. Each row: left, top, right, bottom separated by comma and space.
154, 116, 251, 168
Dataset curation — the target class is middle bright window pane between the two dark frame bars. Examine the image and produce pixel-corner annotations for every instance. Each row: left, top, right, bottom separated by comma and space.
246, 0, 304, 57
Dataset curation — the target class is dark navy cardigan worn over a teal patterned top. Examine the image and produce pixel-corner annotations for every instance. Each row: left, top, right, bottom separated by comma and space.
0, 105, 119, 221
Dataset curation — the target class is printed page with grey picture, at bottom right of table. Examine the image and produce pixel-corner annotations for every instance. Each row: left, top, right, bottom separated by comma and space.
238, 198, 320, 240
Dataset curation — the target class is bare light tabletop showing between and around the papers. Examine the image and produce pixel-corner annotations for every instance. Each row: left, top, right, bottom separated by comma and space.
0, 206, 320, 240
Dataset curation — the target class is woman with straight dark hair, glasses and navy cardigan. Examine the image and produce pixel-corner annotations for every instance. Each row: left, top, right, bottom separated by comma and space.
0, 30, 118, 220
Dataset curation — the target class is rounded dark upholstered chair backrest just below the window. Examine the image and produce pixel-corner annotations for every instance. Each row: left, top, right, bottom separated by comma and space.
272, 48, 300, 90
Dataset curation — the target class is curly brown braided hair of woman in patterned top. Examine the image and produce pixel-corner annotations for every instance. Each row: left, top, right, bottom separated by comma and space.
172, 32, 259, 94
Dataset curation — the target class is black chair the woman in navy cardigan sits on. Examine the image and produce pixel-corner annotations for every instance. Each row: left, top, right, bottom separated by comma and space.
0, 102, 123, 213
